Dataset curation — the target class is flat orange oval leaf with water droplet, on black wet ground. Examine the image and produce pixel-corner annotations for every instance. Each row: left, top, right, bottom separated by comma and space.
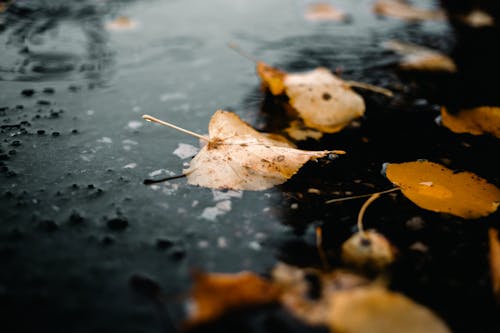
385, 161, 500, 219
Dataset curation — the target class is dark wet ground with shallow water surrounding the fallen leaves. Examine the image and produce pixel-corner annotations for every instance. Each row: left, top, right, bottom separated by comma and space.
0, 0, 500, 332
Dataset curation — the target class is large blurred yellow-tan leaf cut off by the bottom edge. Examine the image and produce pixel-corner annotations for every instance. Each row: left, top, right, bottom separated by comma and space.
328, 287, 451, 333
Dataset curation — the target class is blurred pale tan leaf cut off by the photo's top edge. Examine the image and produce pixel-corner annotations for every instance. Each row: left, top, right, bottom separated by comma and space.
373, 0, 446, 21
